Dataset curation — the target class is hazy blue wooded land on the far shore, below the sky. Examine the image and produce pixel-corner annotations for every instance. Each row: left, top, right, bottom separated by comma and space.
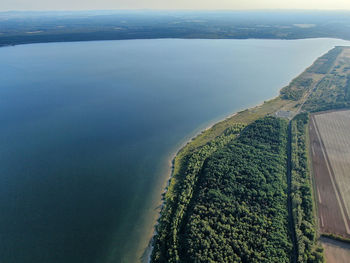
0, 10, 350, 46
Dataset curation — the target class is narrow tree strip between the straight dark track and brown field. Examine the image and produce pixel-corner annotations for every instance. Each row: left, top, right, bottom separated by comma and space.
291, 113, 324, 263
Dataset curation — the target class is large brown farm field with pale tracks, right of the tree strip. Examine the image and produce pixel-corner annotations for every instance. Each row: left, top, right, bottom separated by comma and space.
309, 110, 350, 238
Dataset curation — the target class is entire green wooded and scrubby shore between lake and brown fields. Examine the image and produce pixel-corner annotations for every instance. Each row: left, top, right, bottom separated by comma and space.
152, 47, 350, 263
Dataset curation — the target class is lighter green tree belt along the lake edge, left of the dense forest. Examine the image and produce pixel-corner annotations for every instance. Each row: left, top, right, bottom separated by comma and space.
152, 124, 244, 262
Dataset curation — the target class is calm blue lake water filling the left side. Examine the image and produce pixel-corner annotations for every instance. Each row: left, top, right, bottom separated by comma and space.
0, 39, 348, 263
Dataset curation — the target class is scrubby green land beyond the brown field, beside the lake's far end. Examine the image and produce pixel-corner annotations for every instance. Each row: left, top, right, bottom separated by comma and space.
280, 47, 350, 112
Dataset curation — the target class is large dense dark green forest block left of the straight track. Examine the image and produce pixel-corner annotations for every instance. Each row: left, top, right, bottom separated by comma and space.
152, 117, 292, 262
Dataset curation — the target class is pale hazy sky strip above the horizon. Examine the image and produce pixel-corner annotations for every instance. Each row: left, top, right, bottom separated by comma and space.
0, 0, 350, 10
